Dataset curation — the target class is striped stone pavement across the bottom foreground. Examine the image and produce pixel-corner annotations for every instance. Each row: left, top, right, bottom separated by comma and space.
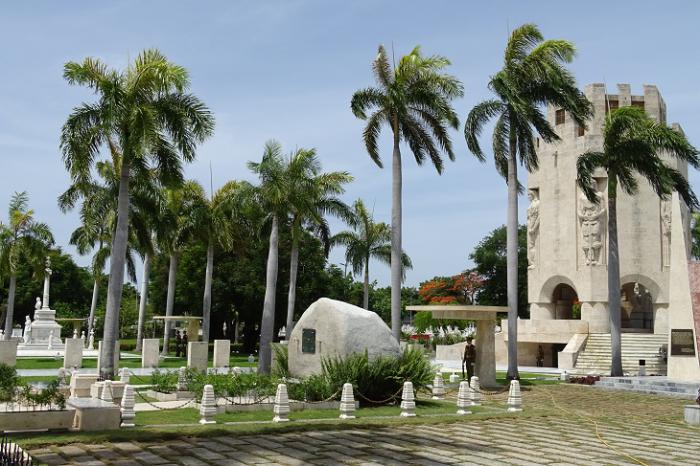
30, 417, 700, 466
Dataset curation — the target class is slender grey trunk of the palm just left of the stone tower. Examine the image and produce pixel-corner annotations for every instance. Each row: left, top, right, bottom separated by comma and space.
506, 129, 520, 380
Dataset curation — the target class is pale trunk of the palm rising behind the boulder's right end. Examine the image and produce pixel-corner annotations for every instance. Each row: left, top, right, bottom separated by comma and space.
391, 129, 402, 341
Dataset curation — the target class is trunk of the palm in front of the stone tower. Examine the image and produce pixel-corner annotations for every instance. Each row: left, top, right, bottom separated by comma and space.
608, 178, 623, 377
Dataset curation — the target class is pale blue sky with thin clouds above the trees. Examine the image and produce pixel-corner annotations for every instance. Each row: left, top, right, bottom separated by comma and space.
0, 0, 700, 286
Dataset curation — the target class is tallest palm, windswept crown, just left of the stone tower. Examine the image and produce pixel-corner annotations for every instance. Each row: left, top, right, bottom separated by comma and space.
464, 24, 591, 379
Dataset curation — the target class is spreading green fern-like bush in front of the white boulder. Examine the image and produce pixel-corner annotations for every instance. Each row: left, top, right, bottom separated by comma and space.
322, 348, 434, 405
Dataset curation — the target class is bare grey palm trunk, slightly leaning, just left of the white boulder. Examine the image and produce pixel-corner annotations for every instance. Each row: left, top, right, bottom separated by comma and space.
258, 215, 279, 374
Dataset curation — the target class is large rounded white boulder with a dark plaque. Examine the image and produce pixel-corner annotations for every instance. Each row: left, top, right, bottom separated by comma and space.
289, 298, 400, 377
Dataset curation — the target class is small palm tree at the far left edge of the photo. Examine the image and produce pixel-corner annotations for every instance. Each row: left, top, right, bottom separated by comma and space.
0, 192, 53, 340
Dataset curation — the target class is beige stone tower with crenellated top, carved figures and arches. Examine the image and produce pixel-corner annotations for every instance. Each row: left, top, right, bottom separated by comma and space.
528, 84, 688, 334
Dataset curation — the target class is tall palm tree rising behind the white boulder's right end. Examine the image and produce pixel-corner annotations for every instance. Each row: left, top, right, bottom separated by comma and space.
350, 46, 464, 341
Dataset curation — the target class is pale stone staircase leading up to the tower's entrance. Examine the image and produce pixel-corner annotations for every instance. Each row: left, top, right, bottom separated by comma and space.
571, 333, 668, 375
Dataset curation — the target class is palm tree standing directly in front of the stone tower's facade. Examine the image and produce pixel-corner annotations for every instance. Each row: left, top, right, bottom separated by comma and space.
577, 107, 700, 377
